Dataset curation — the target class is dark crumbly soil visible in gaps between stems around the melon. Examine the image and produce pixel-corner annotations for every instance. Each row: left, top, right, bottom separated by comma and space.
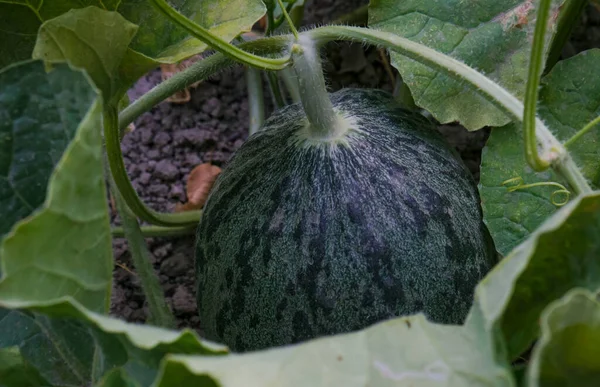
111, 0, 600, 333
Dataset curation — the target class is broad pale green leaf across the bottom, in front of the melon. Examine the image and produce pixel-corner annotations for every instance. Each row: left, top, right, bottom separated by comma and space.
157, 315, 514, 387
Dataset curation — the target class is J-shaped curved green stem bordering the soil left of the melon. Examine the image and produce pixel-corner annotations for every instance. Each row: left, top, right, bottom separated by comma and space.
103, 105, 201, 227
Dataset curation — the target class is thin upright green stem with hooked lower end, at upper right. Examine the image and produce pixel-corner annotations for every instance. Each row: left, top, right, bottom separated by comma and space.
523, 0, 552, 172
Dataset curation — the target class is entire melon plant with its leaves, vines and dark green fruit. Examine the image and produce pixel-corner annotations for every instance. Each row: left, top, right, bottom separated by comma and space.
0, 0, 600, 387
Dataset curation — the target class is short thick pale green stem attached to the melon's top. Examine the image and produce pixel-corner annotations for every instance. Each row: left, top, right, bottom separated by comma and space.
292, 35, 345, 140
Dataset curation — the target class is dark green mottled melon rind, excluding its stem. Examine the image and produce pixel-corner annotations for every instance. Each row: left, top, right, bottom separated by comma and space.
196, 89, 495, 351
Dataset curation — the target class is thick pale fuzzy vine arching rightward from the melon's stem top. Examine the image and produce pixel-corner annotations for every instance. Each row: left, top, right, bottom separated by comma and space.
308, 26, 591, 192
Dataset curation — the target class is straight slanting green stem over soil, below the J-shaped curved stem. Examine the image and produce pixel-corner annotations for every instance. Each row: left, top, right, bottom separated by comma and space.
109, 174, 175, 328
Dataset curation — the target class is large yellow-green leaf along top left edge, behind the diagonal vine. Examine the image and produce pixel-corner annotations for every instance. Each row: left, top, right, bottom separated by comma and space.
0, 0, 265, 68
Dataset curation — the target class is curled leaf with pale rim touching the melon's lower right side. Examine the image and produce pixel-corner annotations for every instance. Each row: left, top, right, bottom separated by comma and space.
466, 192, 600, 359
